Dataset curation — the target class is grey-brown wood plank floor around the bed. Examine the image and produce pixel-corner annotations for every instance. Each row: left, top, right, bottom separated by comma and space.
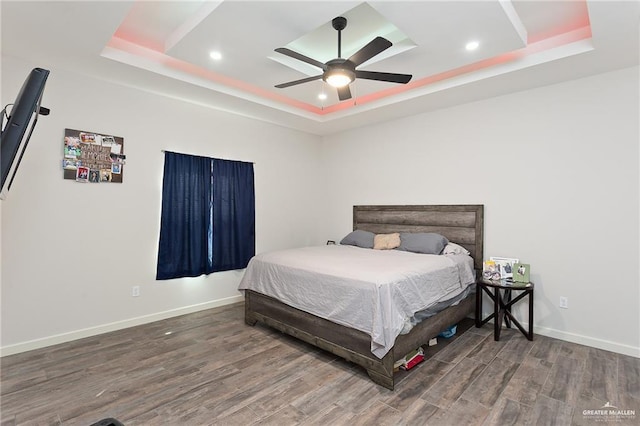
0, 304, 640, 426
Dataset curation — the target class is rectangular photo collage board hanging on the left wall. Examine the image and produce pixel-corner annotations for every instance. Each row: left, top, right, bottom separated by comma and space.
62, 129, 127, 183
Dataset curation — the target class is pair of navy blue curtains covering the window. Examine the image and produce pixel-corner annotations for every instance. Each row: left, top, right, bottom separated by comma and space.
156, 152, 255, 280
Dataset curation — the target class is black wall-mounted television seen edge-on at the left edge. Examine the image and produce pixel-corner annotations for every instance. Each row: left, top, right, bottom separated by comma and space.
0, 68, 49, 199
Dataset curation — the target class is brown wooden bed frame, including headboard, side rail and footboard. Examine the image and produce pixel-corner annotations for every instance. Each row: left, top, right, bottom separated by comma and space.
245, 205, 484, 390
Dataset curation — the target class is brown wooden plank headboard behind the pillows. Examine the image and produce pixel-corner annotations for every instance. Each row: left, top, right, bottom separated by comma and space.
353, 204, 484, 270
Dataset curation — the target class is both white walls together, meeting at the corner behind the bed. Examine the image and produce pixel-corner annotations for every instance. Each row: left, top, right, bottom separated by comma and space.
0, 52, 640, 356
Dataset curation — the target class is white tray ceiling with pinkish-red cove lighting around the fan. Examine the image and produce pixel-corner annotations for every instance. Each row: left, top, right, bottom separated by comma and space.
0, 0, 640, 135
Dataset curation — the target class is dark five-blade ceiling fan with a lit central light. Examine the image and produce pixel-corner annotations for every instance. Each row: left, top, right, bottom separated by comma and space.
275, 16, 412, 101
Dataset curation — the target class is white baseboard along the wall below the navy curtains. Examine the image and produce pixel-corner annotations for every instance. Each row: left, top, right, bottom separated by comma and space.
0, 295, 244, 357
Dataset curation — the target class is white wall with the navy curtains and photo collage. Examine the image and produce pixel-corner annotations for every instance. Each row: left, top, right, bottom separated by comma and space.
0, 57, 323, 354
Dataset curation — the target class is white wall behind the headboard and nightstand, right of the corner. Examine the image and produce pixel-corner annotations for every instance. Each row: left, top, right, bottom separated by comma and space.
323, 67, 640, 356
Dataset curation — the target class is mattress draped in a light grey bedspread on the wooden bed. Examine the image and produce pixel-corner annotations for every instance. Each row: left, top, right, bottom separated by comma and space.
239, 245, 475, 358
